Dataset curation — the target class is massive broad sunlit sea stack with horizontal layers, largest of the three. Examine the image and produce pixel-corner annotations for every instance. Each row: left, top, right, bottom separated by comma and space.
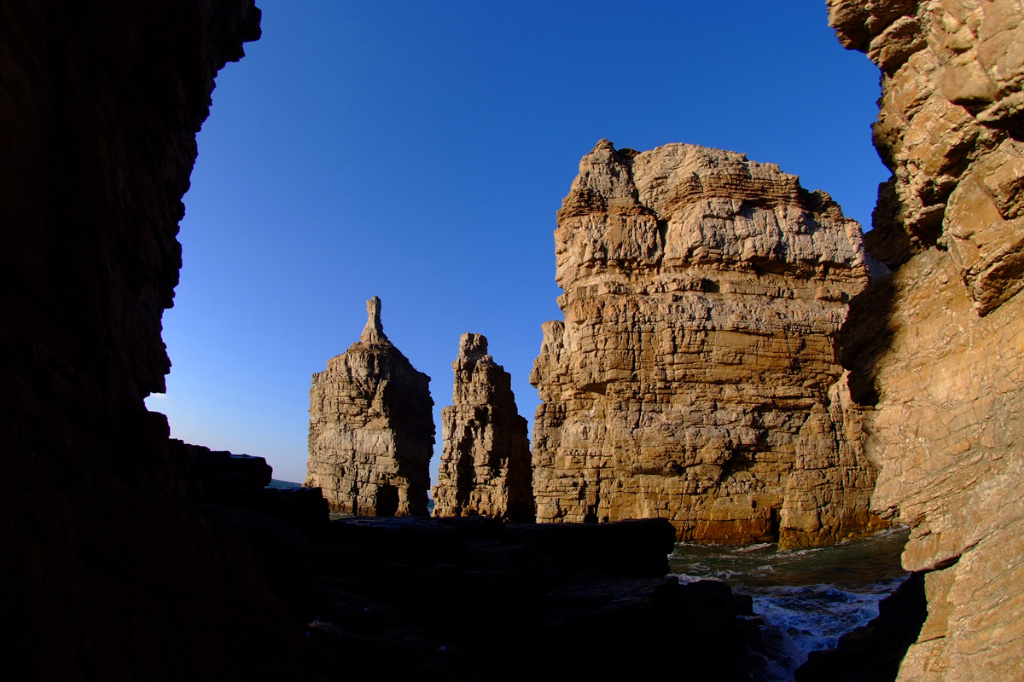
530, 140, 874, 547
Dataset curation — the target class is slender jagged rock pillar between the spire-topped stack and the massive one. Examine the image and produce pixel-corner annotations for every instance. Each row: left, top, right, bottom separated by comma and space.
433, 334, 534, 521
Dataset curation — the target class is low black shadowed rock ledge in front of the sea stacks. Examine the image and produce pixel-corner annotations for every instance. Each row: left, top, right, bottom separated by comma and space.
186, 444, 764, 681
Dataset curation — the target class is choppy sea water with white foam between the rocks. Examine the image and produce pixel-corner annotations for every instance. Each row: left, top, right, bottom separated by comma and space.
669, 528, 909, 682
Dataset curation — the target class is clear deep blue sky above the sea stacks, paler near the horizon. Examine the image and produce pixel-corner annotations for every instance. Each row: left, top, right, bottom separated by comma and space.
147, 0, 888, 481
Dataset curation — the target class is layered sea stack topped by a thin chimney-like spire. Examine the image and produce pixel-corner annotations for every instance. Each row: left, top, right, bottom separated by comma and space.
304, 296, 434, 516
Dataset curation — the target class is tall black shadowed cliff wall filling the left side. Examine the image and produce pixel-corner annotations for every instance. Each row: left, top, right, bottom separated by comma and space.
0, 0, 323, 680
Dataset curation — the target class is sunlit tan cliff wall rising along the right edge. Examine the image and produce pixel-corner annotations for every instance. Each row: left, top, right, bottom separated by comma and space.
829, 0, 1024, 680
